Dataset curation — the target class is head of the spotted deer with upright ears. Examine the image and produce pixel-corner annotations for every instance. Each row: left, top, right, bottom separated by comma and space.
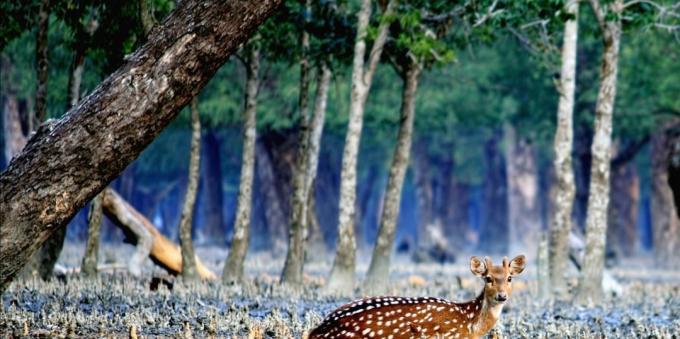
470, 255, 525, 306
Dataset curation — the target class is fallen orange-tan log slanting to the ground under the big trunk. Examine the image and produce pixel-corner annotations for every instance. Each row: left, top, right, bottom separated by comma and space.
102, 188, 217, 280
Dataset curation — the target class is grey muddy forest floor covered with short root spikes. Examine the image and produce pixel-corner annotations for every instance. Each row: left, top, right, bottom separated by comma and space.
0, 243, 680, 338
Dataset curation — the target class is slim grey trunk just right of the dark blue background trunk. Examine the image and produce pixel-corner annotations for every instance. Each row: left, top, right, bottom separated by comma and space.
222, 44, 260, 283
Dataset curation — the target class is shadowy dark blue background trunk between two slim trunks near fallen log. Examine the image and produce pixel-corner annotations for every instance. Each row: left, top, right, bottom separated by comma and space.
198, 132, 225, 245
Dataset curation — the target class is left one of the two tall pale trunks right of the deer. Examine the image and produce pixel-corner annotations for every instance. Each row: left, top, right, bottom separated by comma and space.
548, 0, 579, 296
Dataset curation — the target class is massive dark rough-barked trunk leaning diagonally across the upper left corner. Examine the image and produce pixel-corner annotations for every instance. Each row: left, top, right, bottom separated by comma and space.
0, 0, 281, 291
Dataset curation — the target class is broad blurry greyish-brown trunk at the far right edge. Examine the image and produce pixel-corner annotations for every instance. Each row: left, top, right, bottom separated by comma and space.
651, 121, 680, 269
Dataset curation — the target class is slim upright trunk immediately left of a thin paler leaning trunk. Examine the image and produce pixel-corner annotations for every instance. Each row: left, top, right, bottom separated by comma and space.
281, 15, 310, 287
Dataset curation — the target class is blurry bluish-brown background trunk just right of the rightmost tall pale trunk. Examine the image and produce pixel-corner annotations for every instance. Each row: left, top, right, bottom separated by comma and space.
607, 162, 640, 257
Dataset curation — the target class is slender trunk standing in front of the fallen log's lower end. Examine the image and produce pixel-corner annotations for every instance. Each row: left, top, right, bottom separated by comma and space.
179, 97, 201, 280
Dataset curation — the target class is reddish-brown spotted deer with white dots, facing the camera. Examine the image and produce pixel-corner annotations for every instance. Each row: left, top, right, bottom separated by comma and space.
309, 255, 525, 339
